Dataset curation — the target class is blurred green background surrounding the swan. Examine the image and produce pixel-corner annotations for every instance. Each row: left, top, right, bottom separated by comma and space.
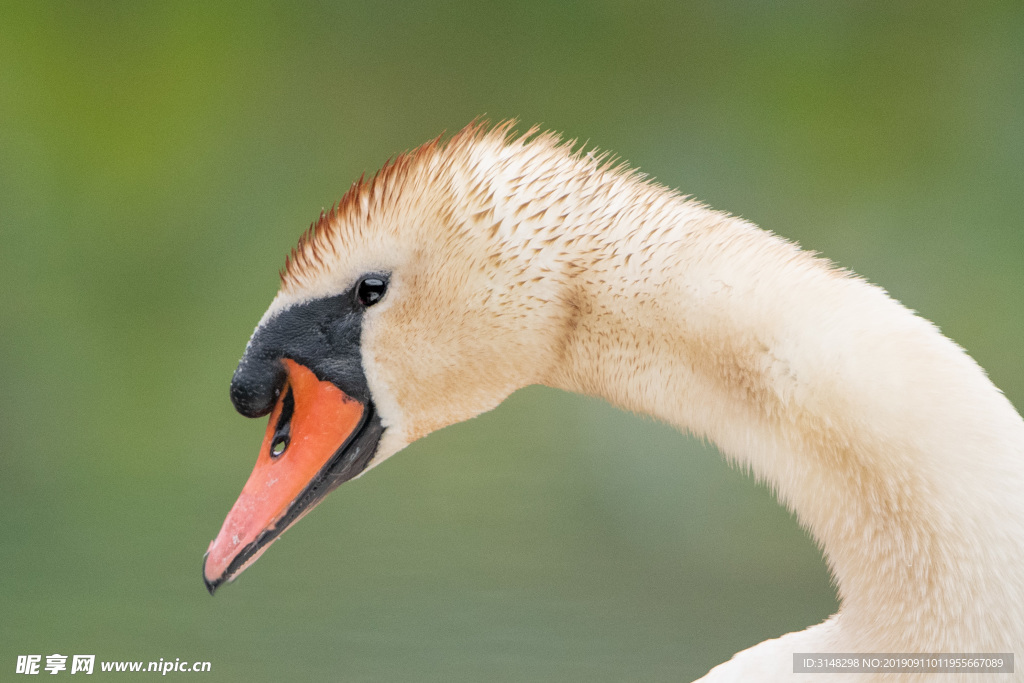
0, 0, 1024, 681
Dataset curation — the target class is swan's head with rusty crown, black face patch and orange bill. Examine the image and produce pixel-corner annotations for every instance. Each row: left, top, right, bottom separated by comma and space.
203, 126, 575, 594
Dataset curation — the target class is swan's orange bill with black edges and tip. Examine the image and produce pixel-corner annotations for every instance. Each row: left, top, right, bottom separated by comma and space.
203, 358, 368, 595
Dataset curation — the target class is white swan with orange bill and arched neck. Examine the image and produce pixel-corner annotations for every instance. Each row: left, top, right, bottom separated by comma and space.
203, 122, 1024, 683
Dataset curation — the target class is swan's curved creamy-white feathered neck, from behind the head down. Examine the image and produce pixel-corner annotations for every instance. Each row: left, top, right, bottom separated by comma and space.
475, 149, 1024, 682
